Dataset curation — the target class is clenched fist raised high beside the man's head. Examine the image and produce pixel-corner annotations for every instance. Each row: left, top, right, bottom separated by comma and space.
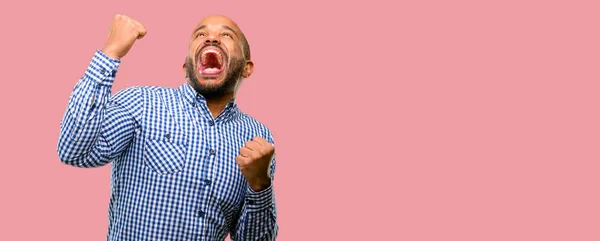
102, 14, 146, 59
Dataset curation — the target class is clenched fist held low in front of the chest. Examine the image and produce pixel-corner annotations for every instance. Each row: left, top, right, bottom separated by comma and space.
235, 137, 275, 192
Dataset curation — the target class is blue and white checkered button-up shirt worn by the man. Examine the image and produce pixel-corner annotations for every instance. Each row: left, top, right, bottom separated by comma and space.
57, 50, 278, 241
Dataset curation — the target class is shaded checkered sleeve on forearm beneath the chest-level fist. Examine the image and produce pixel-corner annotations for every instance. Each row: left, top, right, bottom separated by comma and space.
231, 133, 279, 241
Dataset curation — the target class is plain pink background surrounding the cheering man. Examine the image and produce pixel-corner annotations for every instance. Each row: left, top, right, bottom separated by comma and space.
0, 0, 600, 241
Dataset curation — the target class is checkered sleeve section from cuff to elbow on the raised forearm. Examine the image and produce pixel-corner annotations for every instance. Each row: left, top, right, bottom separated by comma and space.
58, 51, 119, 167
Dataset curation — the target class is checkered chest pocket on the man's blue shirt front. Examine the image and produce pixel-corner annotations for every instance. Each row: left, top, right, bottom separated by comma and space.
144, 138, 187, 175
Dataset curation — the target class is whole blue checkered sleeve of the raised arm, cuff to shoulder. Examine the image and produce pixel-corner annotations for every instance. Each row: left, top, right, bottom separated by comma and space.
57, 50, 142, 167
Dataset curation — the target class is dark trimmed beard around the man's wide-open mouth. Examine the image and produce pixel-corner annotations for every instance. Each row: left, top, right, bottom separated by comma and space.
185, 52, 244, 99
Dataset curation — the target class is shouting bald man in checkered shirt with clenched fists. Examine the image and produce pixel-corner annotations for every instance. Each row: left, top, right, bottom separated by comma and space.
58, 15, 278, 241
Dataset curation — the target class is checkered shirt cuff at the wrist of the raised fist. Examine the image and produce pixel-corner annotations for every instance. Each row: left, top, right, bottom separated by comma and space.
86, 50, 121, 86
